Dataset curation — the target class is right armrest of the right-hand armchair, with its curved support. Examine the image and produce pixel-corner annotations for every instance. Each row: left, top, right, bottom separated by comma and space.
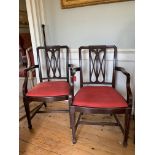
115, 67, 132, 107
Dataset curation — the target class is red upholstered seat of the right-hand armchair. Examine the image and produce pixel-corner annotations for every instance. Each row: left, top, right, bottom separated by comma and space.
73, 86, 128, 108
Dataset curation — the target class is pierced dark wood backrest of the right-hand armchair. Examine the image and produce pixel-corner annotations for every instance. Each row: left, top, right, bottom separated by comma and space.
79, 45, 117, 87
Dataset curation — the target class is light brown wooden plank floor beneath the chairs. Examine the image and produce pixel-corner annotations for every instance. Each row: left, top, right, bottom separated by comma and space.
19, 100, 135, 155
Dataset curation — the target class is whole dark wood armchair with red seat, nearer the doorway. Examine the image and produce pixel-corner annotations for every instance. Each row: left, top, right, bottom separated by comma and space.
23, 46, 71, 129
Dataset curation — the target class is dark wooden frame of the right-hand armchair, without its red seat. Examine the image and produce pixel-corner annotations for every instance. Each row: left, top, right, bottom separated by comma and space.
69, 45, 132, 146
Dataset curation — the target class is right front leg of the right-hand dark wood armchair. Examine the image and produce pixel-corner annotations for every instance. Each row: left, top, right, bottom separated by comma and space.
123, 110, 131, 147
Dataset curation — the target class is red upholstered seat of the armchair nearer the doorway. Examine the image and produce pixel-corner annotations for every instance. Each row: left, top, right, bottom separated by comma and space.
26, 81, 70, 97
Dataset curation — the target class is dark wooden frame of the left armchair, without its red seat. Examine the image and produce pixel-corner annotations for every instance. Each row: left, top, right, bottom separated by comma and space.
23, 46, 72, 129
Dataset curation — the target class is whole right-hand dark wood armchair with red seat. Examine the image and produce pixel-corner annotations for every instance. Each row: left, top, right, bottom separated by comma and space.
69, 45, 132, 146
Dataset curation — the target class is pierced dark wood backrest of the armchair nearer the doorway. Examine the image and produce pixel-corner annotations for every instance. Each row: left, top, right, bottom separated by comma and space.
37, 46, 69, 81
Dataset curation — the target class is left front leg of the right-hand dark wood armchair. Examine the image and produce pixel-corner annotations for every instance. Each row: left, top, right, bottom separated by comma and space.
70, 107, 76, 144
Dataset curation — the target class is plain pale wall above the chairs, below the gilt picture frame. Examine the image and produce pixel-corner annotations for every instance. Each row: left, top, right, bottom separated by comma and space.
44, 0, 135, 49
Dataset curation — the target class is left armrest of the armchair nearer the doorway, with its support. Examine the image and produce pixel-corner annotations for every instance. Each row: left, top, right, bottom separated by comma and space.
23, 65, 39, 96
